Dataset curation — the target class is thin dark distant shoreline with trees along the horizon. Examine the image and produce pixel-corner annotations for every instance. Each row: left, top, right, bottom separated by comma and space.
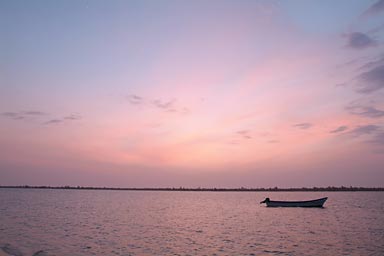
0, 185, 384, 192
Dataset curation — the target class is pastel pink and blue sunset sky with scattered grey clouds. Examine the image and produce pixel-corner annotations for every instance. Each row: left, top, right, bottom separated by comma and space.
0, 0, 384, 187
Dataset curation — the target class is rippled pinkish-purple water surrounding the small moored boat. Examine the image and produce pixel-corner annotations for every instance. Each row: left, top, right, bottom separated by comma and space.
0, 189, 384, 256
